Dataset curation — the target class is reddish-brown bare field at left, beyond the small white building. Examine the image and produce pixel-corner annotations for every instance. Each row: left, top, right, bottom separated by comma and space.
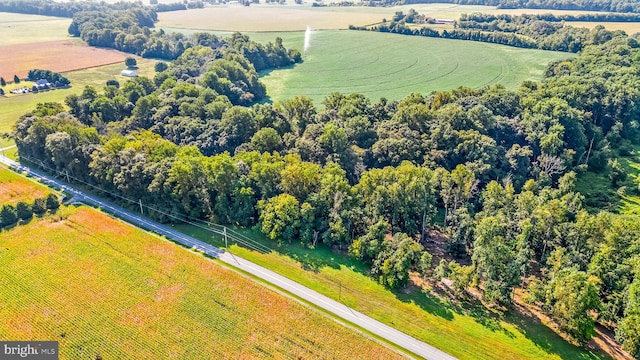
0, 40, 129, 80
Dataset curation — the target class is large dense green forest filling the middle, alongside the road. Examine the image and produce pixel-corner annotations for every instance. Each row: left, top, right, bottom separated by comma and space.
8, 24, 640, 357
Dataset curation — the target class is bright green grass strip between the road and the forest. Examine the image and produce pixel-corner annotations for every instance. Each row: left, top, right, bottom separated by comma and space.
175, 225, 606, 360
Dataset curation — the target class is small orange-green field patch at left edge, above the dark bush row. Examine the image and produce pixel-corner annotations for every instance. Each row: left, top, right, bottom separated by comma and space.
0, 166, 53, 205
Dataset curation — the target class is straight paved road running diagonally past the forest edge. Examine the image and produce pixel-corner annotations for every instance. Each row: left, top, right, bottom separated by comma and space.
0, 155, 455, 360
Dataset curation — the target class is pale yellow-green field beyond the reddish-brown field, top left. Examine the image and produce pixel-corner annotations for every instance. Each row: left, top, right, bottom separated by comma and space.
0, 12, 71, 46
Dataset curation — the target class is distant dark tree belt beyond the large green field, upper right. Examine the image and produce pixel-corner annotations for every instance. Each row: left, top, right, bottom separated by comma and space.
349, 9, 637, 53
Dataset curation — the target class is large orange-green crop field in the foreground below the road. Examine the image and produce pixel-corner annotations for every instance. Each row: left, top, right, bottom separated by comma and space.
0, 207, 400, 359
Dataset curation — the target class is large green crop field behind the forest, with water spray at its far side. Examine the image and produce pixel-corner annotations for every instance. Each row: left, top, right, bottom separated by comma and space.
254, 30, 572, 103
